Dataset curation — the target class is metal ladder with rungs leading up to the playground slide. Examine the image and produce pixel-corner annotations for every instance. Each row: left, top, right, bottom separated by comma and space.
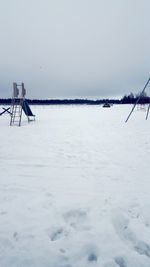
10, 98, 24, 126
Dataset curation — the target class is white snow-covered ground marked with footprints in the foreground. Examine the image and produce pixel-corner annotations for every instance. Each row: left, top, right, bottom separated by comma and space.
0, 105, 150, 267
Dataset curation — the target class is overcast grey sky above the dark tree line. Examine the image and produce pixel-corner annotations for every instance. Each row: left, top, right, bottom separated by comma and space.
0, 0, 150, 98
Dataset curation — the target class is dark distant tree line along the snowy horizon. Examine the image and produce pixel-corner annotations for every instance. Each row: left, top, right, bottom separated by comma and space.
0, 93, 150, 105
